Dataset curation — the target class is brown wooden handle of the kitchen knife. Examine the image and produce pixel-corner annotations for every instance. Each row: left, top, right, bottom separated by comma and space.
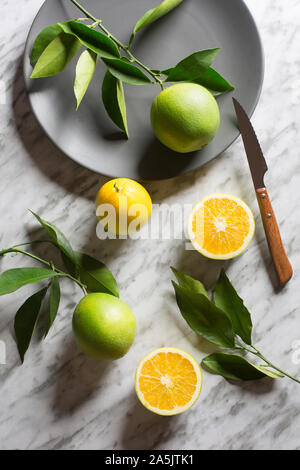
256, 188, 293, 286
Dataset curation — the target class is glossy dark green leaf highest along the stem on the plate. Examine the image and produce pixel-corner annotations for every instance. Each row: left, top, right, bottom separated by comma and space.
59, 21, 120, 59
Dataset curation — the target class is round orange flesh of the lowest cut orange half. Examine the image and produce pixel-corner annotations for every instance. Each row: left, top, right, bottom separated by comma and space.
139, 352, 197, 411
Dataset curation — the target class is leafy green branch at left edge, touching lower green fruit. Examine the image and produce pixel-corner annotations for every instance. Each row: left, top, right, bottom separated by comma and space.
0, 213, 119, 362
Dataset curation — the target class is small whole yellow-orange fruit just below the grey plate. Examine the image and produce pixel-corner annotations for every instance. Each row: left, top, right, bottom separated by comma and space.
96, 178, 152, 235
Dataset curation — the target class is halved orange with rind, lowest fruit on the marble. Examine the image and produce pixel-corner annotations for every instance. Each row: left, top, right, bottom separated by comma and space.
135, 348, 202, 416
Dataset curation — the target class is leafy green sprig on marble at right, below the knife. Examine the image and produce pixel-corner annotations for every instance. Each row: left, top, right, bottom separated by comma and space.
171, 268, 300, 383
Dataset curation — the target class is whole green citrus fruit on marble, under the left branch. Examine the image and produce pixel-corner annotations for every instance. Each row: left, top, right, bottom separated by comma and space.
73, 293, 136, 360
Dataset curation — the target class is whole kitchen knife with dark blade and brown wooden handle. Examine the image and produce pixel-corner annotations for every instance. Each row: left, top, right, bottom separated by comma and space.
232, 98, 293, 286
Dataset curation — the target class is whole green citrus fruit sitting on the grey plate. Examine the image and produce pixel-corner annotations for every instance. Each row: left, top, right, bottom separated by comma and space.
151, 83, 220, 153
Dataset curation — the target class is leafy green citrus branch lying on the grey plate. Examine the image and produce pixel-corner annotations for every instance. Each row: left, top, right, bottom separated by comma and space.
30, 0, 234, 138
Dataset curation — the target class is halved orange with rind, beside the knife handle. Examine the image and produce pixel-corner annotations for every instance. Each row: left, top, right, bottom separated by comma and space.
188, 194, 255, 260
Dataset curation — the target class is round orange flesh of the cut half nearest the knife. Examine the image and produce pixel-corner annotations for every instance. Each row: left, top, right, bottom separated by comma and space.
192, 198, 250, 255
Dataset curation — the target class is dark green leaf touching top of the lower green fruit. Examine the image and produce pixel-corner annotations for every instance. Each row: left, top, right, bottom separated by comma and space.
63, 252, 119, 297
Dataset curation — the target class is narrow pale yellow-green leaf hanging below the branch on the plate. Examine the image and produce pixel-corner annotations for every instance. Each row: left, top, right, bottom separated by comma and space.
74, 49, 98, 109
